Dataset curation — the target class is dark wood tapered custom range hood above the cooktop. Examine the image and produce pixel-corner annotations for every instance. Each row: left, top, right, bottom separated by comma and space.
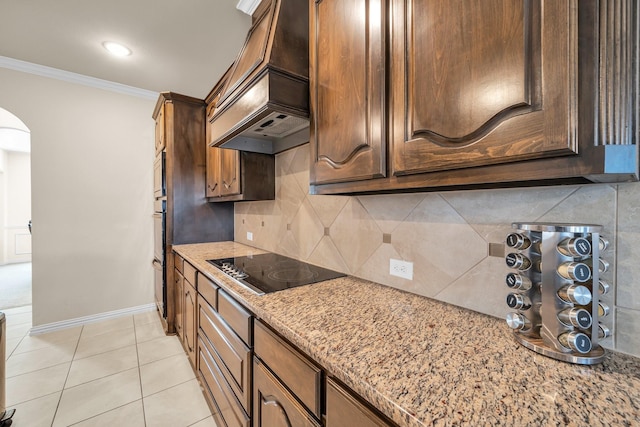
209, 0, 309, 154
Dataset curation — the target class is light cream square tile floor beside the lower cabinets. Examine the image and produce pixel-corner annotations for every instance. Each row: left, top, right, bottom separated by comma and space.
3, 306, 216, 427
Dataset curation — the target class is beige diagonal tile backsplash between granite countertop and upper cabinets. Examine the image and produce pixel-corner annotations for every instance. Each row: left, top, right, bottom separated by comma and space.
235, 144, 640, 356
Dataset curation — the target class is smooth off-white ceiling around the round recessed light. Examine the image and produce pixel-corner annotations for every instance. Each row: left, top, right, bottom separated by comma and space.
0, 0, 251, 98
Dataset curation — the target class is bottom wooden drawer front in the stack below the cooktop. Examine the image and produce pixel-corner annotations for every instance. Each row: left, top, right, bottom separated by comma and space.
198, 339, 251, 427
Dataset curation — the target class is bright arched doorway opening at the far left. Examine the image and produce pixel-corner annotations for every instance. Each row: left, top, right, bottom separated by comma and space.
0, 108, 32, 310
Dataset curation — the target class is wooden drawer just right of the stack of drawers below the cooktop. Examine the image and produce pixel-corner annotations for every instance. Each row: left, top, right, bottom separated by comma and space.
254, 321, 322, 418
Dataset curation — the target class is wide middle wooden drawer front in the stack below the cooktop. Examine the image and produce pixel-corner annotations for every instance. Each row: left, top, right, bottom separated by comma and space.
198, 299, 251, 412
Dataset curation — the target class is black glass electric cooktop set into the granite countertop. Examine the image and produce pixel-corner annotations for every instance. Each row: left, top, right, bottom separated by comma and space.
207, 253, 345, 295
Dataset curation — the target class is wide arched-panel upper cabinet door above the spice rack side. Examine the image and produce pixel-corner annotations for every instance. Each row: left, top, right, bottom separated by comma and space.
391, 0, 577, 175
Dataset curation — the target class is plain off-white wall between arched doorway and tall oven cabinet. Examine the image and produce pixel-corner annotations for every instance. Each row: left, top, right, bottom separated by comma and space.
0, 68, 155, 326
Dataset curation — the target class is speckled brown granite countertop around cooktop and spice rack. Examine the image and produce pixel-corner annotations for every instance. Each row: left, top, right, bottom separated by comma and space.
173, 242, 640, 426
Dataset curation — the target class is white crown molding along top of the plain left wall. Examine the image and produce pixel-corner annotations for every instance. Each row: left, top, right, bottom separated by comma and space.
0, 56, 158, 100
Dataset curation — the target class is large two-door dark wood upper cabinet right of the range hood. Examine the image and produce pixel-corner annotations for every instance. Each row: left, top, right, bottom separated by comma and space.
309, 0, 640, 194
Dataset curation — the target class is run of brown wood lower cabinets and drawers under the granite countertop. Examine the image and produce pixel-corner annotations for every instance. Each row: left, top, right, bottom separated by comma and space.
174, 254, 395, 427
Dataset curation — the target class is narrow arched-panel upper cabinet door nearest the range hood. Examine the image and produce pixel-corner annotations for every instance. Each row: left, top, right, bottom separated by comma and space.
310, 0, 386, 184
